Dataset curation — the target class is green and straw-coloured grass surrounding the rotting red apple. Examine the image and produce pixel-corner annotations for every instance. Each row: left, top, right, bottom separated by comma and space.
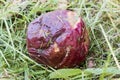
0, 0, 120, 80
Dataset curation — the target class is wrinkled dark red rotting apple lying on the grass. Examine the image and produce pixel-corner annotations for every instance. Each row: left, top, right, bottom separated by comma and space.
27, 10, 89, 68
